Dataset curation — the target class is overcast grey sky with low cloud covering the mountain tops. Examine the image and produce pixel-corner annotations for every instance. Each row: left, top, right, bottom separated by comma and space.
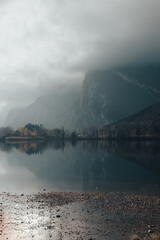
0, 0, 160, 120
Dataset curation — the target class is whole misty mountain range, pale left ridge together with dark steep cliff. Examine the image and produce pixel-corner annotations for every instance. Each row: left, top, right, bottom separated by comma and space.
5, 64, 160, 129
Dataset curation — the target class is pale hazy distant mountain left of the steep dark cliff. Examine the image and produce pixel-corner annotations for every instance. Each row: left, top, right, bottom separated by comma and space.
5, 89, 79, 128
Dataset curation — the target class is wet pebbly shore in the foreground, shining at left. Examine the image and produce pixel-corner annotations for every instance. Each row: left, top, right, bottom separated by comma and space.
0, 192, 160, 240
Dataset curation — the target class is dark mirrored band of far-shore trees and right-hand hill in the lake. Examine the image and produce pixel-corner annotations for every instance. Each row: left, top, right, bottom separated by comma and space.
0, 141, 160, 172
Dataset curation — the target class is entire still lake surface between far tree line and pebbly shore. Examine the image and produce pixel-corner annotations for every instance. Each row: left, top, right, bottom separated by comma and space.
0, 141, 160, 193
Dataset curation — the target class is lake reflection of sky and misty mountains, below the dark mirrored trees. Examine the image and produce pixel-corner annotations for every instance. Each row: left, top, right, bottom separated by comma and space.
0, 144, 159, 193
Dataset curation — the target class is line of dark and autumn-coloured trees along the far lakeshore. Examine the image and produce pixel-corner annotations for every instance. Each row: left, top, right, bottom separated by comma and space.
0, 121, 160, 141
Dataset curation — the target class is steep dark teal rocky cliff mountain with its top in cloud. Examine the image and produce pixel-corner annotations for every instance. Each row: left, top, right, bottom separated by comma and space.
80, 65, 160, 126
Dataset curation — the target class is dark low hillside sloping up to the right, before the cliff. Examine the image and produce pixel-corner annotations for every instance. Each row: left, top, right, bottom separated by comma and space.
102, 102, 160, 138
